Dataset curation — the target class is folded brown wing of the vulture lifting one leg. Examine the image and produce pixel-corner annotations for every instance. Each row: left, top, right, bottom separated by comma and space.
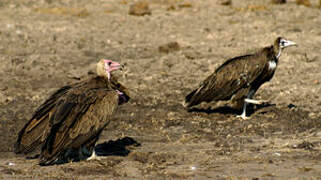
185, 55, 266, 107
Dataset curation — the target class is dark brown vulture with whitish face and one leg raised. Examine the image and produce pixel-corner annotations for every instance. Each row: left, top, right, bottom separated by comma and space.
183, 37, 296, 119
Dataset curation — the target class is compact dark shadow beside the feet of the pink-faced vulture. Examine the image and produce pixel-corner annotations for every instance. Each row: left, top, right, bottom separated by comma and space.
95, 137, 141, 156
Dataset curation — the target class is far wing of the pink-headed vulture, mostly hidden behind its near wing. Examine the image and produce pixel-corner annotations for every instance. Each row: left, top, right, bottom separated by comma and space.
14, 86, 71, 154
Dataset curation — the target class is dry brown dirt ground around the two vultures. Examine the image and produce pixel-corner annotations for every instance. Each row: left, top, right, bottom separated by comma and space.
0, 0, 321, 179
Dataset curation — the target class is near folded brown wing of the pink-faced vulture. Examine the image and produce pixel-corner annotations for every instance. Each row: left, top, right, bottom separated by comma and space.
40, 88, 118, 165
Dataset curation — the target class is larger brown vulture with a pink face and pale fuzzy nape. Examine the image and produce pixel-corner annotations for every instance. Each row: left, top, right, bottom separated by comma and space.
15, 59, 129, 165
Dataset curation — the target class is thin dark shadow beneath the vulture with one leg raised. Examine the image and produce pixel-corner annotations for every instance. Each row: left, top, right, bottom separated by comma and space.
188, 103, 275, 116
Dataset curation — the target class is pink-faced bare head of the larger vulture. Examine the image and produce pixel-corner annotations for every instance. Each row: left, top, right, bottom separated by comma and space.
97, 59, 123, 80
